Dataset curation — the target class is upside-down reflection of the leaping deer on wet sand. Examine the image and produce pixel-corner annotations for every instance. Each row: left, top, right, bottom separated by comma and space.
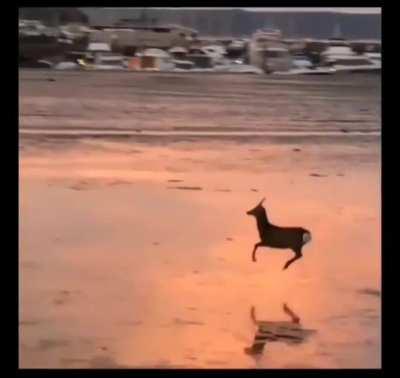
244, 304, 315, 356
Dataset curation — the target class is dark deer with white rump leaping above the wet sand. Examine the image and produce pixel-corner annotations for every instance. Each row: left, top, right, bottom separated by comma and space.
246, 198, 311, 270
